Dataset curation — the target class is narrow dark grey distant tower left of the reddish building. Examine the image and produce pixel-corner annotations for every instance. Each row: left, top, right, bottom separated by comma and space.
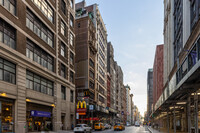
146, 69, 153, 123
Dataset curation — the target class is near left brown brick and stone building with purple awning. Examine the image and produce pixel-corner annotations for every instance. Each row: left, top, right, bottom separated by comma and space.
0, 0, 75, 133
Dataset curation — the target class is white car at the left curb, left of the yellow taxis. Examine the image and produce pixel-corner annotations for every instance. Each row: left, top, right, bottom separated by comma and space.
74, 124, 92, 133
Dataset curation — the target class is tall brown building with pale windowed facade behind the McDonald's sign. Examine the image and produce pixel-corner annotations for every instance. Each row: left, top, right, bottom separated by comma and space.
76, 1, 109, 122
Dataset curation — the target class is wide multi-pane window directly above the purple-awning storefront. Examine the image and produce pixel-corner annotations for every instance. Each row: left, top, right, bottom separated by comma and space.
26, 71, 53, 96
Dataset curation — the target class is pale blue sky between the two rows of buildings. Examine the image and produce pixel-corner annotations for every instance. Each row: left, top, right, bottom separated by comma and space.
76, 0, 164, 116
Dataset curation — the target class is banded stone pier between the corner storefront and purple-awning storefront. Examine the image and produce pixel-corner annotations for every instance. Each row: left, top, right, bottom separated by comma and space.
15, 65, 26, 133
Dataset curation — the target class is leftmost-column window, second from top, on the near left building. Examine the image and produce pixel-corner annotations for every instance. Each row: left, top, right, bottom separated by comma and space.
0, 19, 16, 49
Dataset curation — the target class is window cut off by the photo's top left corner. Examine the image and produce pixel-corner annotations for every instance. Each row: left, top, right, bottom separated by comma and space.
0, 0, 16, 15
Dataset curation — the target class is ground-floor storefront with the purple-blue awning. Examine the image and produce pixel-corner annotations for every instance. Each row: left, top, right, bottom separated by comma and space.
26, 103, 53, 132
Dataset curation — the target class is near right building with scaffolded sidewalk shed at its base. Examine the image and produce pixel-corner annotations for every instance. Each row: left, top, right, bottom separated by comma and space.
154, 0, 200, 133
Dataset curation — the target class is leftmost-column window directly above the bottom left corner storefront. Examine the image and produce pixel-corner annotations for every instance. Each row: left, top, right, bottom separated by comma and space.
0, 58, 16, 84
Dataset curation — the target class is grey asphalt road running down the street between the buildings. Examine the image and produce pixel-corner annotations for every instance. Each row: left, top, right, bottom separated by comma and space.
93, 126, 149, 133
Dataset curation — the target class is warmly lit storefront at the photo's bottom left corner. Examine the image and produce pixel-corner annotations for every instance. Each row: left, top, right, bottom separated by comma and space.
0, 98, 14, 133
